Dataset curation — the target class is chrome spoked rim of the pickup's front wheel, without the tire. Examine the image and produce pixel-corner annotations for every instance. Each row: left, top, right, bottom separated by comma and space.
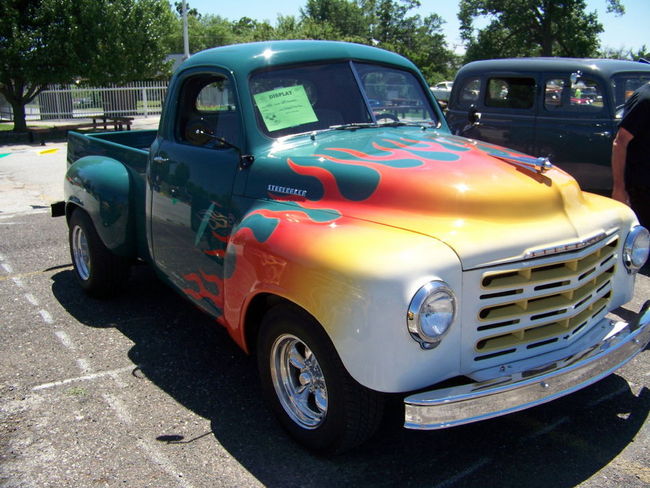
271, 334, 327, 430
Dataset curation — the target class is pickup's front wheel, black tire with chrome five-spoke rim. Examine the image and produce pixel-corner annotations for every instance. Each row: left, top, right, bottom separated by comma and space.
257, 305, 384, 454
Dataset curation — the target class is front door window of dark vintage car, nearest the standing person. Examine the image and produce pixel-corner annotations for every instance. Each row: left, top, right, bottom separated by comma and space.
544, 78, 603, 113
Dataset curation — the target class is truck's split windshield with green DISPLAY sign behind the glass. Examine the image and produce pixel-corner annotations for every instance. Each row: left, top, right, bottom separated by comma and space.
250, 62, 437, 137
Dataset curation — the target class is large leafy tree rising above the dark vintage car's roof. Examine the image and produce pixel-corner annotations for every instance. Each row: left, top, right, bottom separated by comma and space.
458, 0, 625, 61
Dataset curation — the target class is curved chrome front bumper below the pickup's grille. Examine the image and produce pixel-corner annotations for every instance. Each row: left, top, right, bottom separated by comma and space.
404, 300, 650, 430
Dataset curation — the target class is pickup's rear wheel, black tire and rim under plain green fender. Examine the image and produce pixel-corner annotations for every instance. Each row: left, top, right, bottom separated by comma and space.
68, 209, 130, 297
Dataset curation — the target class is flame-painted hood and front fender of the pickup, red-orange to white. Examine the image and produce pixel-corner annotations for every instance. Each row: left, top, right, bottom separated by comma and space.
170, 123, 629, 391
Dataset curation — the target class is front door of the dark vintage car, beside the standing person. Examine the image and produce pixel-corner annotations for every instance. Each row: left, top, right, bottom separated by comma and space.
535, 73, 617, 190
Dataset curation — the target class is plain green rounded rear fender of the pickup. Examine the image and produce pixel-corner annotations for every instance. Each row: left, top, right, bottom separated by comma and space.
64, 156, 136, 257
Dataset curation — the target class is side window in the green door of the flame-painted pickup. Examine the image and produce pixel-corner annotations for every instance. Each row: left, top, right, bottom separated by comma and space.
176, 74, 242, 148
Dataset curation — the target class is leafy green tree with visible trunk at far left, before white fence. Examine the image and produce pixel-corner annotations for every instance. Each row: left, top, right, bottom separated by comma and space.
0, 0, 173, 131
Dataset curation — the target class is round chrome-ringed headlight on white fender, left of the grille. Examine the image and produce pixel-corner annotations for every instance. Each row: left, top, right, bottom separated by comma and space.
406, 281, 456, 349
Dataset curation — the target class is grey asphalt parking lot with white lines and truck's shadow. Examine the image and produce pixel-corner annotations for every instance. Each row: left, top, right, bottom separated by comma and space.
0, 138, 650, 488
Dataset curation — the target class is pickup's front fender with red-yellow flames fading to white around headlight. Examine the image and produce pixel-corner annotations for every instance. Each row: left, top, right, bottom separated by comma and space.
218, 203, 461, 392
